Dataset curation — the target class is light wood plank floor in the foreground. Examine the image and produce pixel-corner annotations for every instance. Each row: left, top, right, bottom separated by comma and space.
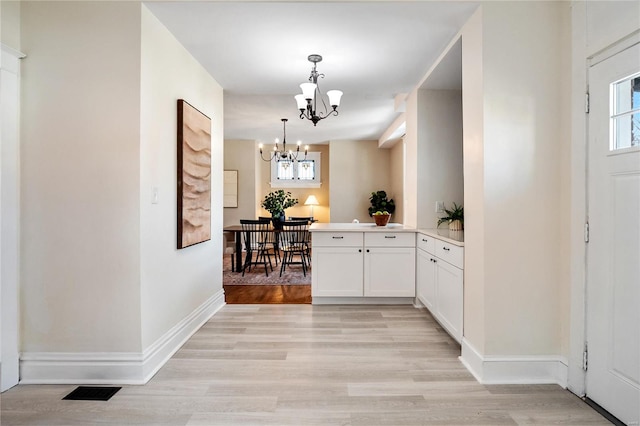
0, 305, 608, 426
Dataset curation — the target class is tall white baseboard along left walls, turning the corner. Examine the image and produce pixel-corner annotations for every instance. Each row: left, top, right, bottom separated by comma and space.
20, 290, 225, 385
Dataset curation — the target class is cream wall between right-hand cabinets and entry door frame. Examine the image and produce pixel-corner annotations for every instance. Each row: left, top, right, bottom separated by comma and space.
462, 2, 570, 381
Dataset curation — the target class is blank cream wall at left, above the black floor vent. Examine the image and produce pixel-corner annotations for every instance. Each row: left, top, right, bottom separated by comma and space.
20, 2, 142, 353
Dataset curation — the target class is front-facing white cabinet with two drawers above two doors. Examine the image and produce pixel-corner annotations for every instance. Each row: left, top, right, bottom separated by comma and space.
311, 231, 416, 298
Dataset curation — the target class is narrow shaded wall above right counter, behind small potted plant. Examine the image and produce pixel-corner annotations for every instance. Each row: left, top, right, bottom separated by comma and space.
417, 90, 464, 228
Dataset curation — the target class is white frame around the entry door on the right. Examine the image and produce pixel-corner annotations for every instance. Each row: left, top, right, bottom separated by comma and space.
567, 25, 640, 397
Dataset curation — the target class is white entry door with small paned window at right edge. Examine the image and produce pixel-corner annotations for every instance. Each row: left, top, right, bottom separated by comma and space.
586, 44, 640, 425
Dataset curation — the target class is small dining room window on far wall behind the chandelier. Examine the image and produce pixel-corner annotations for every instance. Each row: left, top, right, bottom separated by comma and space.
271, 152, 321, 188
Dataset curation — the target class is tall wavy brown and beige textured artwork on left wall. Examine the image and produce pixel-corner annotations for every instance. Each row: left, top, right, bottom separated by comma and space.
178, 99, 211, 249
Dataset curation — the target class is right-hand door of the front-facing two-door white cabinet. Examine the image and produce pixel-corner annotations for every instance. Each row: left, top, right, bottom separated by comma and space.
364, 247, 416, 297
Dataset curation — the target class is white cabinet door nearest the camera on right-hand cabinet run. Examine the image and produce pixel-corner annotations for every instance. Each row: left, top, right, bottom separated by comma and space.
435, 259, 464, 343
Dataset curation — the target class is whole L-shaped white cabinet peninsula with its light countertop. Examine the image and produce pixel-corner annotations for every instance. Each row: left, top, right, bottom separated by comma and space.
310, 223, 464, 342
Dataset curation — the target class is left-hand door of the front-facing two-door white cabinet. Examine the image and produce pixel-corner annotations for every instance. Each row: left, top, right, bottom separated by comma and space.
311, 246, 363, 297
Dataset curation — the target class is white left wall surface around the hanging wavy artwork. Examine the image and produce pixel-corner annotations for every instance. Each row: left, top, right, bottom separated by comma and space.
139, 5, 223, 349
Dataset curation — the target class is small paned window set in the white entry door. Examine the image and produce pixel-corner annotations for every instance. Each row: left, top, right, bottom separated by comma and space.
609, 73, 640, 151
